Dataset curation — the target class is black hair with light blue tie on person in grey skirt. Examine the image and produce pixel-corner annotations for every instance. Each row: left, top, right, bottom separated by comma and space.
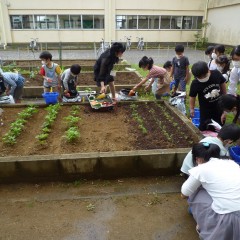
192, 142, 220, 166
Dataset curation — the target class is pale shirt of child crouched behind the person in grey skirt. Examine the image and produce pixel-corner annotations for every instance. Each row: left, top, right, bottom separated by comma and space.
181, 137, 228, 175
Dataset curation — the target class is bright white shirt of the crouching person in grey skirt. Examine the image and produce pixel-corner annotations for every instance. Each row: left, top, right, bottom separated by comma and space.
187, 158, 240, 214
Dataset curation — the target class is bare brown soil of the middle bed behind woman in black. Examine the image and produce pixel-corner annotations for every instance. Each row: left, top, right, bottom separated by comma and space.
23, 72, 141, 87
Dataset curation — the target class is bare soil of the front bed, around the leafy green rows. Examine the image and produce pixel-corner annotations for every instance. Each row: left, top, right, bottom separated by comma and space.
0, 102, 198, 156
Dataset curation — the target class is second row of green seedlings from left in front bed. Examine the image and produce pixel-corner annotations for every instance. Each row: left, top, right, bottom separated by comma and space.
36, 104, 60, 145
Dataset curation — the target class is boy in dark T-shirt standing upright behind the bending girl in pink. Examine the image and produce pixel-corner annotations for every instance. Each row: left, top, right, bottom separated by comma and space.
170, 45, 189, 96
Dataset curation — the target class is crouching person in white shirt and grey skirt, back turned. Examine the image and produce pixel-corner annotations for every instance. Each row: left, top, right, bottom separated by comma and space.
181, 143, 240, 240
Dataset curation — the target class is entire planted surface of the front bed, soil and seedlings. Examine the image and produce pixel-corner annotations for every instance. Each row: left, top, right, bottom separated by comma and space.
0, 102, 197, 156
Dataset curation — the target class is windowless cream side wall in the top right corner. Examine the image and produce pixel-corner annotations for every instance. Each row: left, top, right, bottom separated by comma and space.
207, 0, 240, 46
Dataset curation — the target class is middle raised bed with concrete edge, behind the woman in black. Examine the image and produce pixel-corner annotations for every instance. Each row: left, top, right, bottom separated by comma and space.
23, 71, 141, 98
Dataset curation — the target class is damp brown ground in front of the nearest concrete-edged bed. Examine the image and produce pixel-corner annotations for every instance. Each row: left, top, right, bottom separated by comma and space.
0, 177, 199, 240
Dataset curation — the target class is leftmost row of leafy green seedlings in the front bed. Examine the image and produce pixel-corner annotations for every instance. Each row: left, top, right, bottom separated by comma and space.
2, 105, 38, 145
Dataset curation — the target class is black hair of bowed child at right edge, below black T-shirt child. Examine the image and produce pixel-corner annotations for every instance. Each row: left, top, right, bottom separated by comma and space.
218, 123, 240, 142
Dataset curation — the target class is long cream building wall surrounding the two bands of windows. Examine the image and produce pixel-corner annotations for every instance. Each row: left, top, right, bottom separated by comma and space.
0, 0, 206, 43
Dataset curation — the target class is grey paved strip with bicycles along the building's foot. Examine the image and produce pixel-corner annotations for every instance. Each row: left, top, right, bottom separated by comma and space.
0, 48, 207, 64
